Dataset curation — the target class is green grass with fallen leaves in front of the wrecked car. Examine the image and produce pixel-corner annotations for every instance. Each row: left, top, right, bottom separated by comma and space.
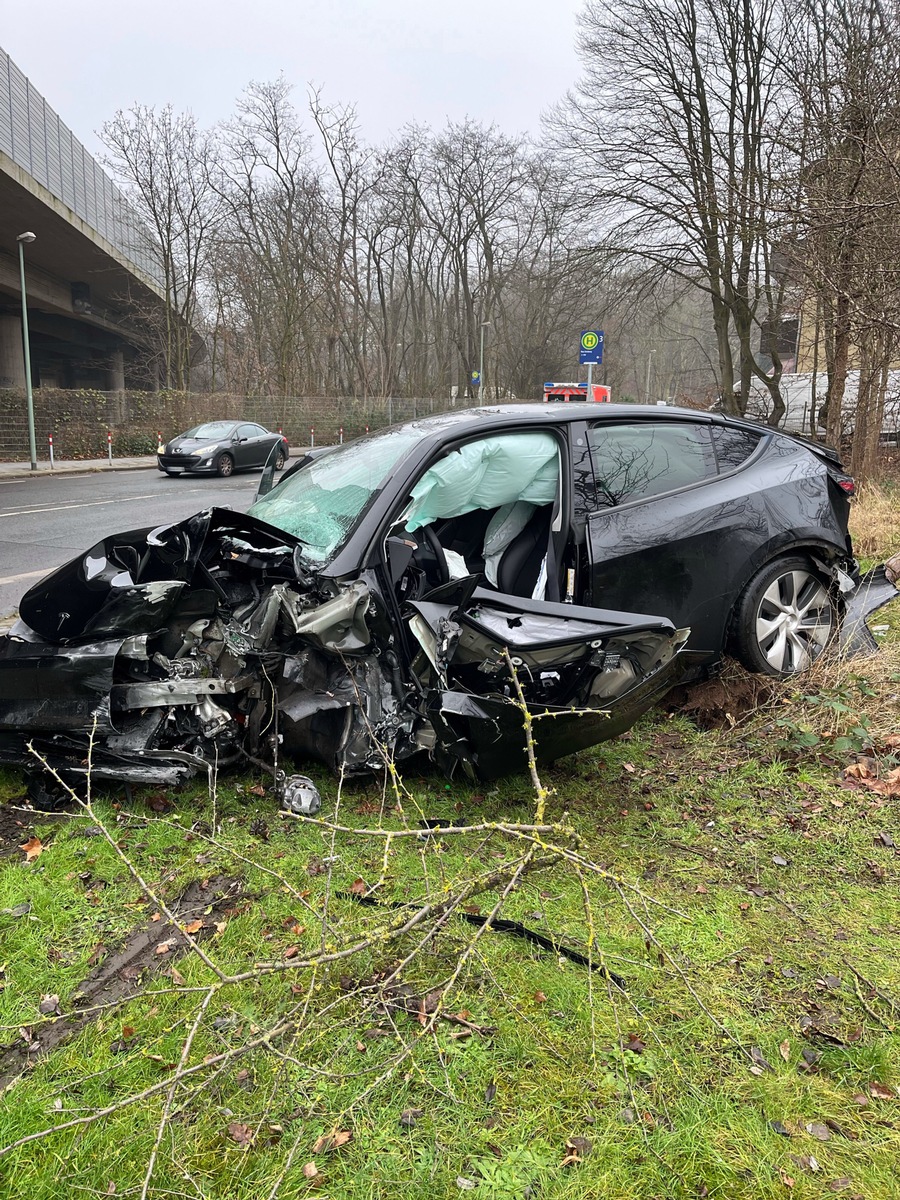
0, 643, 900, 1200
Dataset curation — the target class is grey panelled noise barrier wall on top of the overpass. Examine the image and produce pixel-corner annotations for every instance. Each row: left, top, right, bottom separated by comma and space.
0, 49, 163, 288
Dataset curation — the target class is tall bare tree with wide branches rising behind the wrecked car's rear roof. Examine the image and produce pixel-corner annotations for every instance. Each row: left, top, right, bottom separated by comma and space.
554, 0, 784, 422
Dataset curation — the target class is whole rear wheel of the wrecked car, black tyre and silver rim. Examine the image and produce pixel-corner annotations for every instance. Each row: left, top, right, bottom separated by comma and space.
732, 554, 839, 678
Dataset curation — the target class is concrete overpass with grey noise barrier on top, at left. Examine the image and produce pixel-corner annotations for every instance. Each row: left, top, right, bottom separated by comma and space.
0, 49, 164, 390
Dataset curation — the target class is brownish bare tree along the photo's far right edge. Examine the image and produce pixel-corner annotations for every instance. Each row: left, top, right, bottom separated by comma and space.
785, 0, 900, 478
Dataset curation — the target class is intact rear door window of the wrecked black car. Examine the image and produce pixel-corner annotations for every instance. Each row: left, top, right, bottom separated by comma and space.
588, 421, 716, 508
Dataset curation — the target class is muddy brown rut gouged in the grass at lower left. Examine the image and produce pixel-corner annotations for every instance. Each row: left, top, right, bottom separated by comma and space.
0, 876, 244, 1091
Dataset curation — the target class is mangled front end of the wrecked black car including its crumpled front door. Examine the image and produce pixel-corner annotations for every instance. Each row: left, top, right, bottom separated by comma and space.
0, 509, 686, 811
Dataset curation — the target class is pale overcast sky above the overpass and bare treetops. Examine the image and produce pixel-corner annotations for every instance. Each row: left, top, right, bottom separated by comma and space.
0, 0, 581, 154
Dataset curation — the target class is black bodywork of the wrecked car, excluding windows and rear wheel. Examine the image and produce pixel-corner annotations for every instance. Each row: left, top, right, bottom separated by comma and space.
0, 404, 883, 782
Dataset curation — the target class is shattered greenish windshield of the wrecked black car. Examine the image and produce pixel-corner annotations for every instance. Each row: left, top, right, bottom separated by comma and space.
250, 425, 428, 563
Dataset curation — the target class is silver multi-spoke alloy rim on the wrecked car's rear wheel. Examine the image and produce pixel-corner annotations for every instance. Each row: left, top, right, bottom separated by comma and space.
756, 570, 834, 674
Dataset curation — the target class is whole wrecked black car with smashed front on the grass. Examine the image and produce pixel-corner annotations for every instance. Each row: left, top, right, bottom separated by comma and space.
0, 404, 888, 806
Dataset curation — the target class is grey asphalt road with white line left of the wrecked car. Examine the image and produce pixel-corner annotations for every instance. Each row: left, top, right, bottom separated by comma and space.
0, 468, 260, 617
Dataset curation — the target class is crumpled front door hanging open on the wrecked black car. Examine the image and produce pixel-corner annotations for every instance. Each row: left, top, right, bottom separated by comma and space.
408, 578, 689, 780
